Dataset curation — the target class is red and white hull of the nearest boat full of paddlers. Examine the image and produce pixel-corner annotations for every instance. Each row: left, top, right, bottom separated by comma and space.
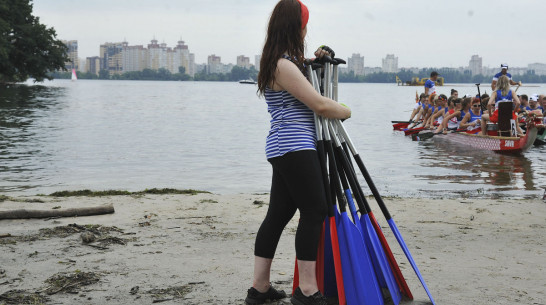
433, 128, 537, 154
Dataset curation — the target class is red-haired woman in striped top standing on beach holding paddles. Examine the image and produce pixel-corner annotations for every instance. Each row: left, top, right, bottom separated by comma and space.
245, 0, 351, 305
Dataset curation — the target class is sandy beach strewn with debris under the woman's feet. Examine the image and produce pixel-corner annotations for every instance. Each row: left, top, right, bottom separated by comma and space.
0, 193, 546, 305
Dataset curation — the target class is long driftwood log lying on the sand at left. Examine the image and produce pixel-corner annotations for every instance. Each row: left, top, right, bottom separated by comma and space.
0, 204, 114, 220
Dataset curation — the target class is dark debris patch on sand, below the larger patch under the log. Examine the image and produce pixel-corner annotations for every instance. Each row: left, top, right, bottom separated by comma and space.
43, 270, 100, 295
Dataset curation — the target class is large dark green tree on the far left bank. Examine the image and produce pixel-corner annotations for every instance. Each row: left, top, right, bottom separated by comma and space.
0, 0, 68, 83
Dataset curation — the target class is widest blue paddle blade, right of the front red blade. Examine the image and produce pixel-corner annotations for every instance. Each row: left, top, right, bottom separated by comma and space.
338, 212, 384, 305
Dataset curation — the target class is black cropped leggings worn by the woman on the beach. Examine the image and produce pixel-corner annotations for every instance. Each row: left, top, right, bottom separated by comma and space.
254, 150, 327, 261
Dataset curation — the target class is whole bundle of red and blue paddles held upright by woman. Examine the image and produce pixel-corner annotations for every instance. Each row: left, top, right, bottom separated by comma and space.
293, 56, 435, 305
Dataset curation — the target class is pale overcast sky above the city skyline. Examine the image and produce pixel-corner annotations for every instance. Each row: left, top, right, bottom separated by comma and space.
33, 0, 546, 67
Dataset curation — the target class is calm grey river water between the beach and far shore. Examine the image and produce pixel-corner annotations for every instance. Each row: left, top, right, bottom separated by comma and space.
0, 80, 546, 198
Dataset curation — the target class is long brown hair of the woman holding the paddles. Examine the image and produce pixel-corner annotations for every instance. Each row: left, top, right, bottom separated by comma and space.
258, 0, 305, 95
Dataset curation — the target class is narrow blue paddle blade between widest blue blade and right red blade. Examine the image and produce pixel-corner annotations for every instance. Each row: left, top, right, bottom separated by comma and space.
360, 214, 402, 305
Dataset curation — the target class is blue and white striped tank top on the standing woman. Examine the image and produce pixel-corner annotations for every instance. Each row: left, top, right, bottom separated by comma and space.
264, 88, 316, 159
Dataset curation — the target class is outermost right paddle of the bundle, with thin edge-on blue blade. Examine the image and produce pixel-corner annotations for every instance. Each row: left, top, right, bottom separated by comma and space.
337, 121, 435, 304
